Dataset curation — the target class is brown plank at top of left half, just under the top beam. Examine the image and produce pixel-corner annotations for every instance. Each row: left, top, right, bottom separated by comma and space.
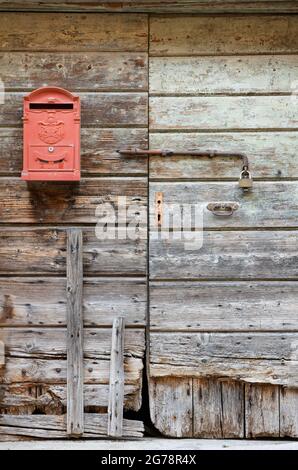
0, 13, 148, 52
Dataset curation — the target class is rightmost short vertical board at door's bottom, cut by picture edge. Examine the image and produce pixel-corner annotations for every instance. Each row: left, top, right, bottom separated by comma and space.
280, 387, 298, 438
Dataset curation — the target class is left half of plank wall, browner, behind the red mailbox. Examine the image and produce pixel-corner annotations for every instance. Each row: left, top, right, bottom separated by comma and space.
0, 13, 148, 437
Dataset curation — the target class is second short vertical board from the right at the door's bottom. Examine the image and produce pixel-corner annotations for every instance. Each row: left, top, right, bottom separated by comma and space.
245, 384, 279, 438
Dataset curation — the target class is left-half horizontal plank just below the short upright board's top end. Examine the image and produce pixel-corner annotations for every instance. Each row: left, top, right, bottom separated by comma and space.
3, 328, 145, 361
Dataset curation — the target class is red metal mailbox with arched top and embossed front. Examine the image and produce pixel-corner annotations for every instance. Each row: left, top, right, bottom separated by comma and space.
22, 87, 80, 181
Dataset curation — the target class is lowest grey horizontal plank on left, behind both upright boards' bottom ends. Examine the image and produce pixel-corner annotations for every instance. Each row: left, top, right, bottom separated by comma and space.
0, 413, 144, 439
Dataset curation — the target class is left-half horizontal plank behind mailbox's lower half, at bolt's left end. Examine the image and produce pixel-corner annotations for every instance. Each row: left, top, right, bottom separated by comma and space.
0, 128, 148, 176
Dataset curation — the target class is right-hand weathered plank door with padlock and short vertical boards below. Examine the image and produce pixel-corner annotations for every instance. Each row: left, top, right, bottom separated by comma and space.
148, 15, 298, 438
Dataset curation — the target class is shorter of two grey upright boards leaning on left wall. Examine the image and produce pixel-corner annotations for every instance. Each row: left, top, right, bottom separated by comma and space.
108, 317, 125, 437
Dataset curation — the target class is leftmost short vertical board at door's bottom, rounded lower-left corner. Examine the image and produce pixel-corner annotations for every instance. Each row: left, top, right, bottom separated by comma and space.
149, 377, 193, 437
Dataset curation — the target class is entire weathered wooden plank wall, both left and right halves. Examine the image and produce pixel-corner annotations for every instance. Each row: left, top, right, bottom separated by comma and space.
0, 10, 298, 439
